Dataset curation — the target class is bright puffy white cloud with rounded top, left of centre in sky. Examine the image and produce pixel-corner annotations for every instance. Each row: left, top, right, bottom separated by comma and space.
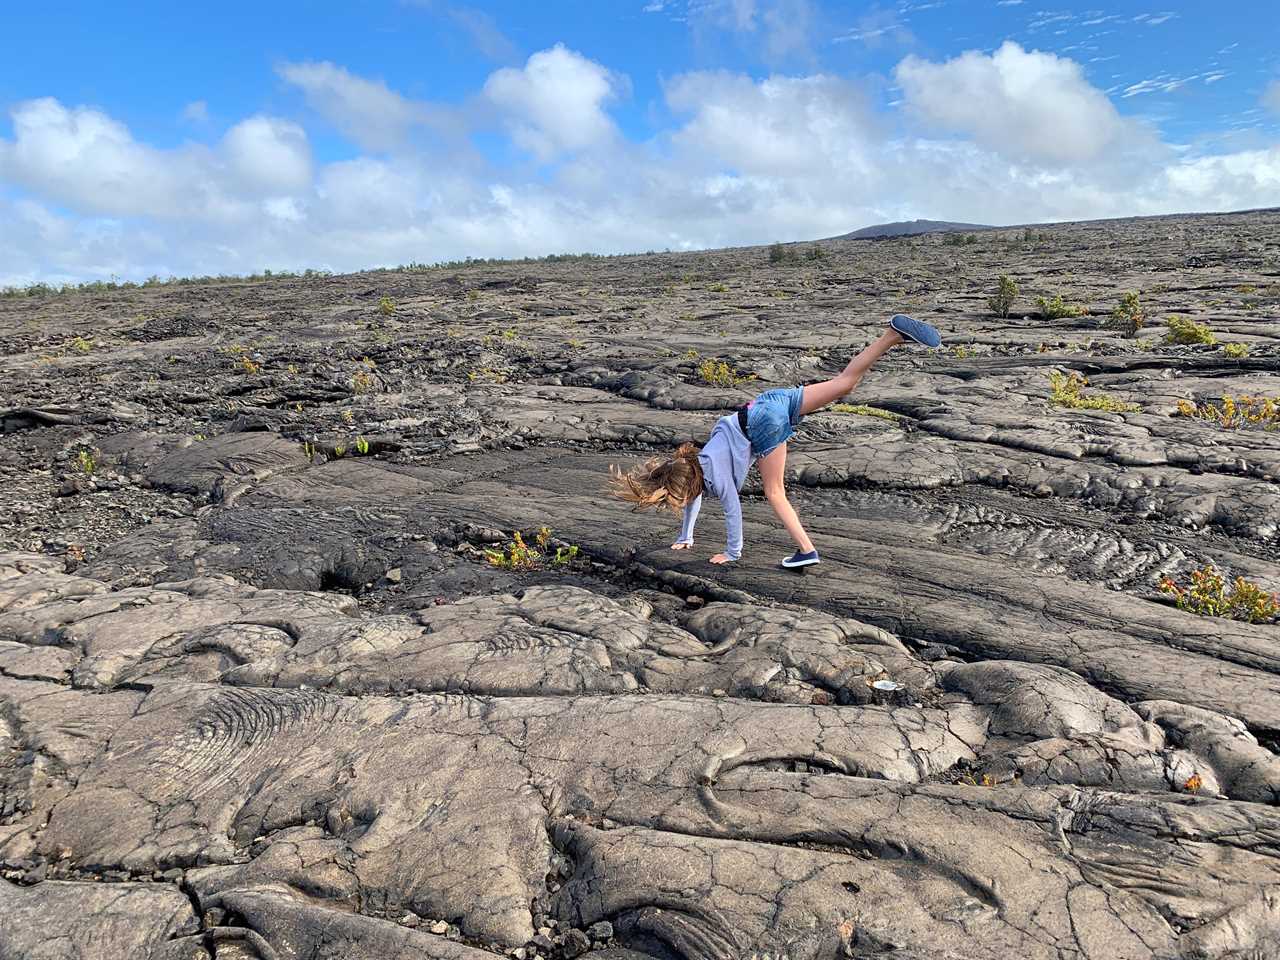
484, 44, 626, 161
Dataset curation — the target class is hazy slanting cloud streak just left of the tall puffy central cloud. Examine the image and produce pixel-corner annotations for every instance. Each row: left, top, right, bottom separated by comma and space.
276, 61, 426, 150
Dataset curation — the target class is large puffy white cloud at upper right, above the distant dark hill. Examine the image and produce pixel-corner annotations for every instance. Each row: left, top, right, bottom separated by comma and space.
893, 41, 1128, 164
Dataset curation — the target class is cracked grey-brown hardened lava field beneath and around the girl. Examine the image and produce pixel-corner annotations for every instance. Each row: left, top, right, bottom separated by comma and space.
0, 211, 1280, 960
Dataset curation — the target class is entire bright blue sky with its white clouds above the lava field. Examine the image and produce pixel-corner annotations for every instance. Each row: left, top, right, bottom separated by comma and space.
0, 0, 1280, 284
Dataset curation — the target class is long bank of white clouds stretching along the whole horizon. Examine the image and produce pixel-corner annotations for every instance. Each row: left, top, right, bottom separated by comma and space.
0, 41, 1280, 285
